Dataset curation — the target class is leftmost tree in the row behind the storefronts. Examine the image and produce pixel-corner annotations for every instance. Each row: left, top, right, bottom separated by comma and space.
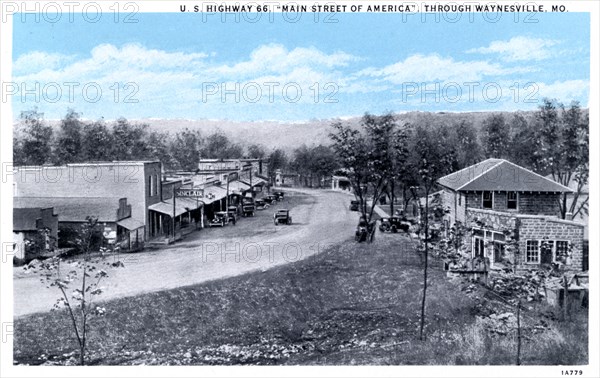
14, 109, 53, 165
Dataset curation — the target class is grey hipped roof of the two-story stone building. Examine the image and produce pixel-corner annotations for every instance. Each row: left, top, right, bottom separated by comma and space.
438, 159, 572, 193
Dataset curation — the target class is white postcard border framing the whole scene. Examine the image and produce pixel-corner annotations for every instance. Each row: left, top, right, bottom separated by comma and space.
0, 0, 600, 377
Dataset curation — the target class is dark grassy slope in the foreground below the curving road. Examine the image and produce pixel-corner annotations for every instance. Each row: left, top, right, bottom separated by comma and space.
14, 234, 588, 365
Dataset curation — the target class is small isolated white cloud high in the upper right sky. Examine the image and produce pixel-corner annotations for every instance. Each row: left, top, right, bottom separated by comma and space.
467, 36, 559, 62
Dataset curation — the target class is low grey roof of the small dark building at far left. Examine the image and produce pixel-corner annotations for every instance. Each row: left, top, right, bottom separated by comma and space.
13, 197, 119, 222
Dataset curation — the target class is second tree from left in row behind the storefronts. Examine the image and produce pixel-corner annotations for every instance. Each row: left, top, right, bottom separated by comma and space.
54, 109, 83, 165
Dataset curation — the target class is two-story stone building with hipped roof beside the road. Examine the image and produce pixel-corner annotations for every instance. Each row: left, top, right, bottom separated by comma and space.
438, 159, 584, 271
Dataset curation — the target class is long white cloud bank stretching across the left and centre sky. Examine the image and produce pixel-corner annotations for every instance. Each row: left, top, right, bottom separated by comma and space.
13, 44, 358, 113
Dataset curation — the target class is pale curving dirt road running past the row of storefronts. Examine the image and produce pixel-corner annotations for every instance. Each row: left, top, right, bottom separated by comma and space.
13, 189, 357, 317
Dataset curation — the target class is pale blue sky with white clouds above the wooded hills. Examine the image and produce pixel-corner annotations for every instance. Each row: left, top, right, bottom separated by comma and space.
13, 13, 590, 121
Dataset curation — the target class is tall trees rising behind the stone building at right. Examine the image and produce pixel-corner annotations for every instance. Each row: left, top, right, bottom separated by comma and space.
330, 99, 589, 219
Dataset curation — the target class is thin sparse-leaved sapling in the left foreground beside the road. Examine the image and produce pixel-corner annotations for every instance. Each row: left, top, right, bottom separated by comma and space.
40, 217, 124, 366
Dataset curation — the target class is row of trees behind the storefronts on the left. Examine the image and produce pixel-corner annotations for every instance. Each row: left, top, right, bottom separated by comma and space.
13, 110, 282, 171
